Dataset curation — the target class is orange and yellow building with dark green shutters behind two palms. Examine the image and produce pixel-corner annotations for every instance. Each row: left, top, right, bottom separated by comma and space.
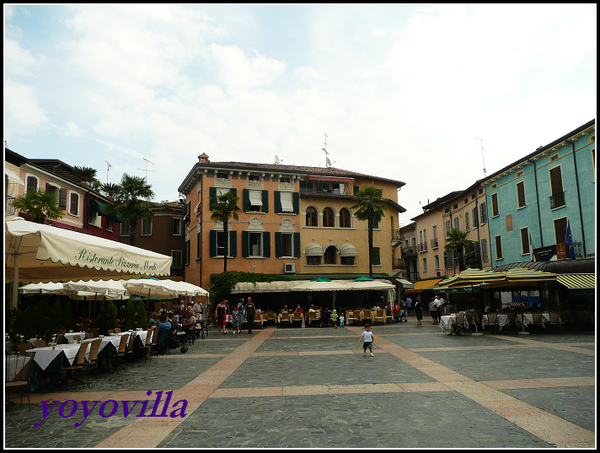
178, 154, 404, 289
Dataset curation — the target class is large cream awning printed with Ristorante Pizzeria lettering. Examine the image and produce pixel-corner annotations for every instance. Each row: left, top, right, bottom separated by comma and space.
4, 218, 173, 307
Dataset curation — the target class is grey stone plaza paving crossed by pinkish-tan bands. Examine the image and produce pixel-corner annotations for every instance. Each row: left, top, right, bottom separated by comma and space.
4, 318, 596, 449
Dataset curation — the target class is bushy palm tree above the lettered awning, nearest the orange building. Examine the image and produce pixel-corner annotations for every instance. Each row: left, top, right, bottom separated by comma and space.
102, 173, 154, 245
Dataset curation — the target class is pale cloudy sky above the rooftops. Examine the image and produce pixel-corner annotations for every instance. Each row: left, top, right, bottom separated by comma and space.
3, 4, 597, 222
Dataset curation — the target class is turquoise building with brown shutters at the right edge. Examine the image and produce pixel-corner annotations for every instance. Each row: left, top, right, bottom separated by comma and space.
482, 120, 596, 268
